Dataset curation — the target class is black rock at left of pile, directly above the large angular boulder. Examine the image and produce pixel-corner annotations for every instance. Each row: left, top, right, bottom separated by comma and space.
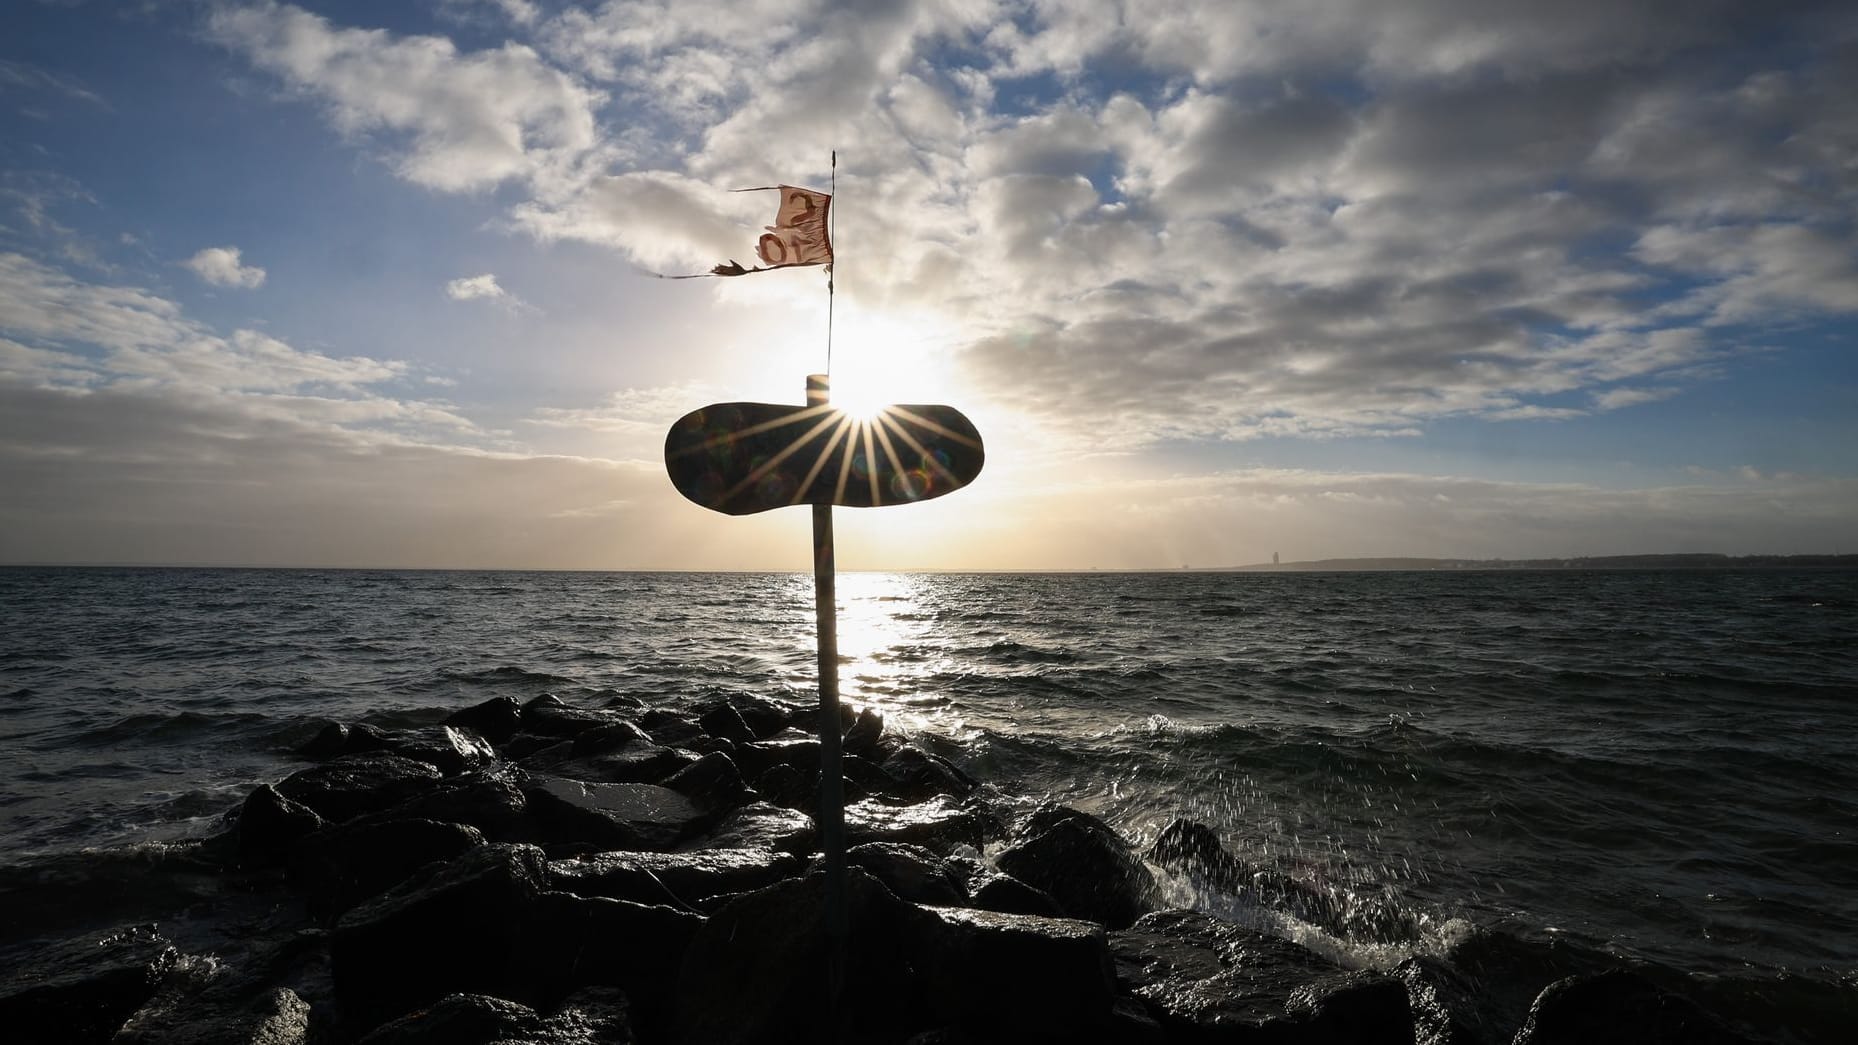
290, 820, 483, 919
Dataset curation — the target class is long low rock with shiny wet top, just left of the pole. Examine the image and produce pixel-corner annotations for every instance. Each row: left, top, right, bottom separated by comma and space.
548, 836, 801, 907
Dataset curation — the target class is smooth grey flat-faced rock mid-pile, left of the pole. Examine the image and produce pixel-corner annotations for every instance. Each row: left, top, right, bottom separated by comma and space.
524, 777, 706, 850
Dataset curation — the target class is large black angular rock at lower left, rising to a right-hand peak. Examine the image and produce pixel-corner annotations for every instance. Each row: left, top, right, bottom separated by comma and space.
329, 842, 548, 1026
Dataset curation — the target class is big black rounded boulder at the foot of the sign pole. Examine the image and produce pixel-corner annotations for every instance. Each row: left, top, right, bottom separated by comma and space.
676, 870, 929, 1045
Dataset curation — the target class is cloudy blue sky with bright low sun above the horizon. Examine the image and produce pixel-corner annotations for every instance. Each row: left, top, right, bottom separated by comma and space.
0, 0, 1858, 569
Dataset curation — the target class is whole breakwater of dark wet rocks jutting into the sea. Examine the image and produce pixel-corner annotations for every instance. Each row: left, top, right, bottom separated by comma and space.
0, 695, 1768, 1045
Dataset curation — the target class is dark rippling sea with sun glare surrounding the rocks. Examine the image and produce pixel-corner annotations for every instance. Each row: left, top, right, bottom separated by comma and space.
0, 567, 1858, 1039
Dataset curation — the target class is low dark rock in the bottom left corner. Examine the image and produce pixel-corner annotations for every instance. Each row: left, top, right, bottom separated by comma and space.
0, 926, 182, 1045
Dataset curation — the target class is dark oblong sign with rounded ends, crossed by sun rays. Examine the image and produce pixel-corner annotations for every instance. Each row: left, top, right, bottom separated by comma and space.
665, 403, 987, 515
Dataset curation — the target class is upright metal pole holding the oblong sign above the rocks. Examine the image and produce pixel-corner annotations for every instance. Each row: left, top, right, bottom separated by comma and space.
806, 374, 851, 1030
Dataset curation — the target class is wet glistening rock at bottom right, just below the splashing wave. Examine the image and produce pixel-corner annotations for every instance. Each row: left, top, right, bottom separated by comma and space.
1109, 911, 1414, 1045
